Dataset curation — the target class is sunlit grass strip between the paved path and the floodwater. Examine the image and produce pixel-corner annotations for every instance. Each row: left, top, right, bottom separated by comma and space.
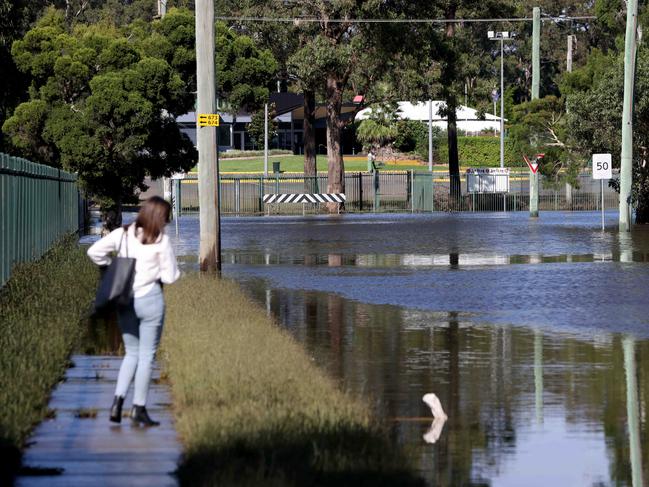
160, 275, 421, 486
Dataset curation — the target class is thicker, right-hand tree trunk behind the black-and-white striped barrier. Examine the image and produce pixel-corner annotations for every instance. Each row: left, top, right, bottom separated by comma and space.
327, 76, 345, 213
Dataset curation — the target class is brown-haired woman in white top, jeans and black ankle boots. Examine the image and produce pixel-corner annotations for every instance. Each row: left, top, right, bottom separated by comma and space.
88, 196, 180, 426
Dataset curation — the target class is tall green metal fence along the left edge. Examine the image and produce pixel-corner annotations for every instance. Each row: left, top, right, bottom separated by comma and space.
0, 153, 79, 286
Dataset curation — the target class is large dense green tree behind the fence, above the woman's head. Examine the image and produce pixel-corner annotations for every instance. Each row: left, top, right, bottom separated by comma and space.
3, 9, 197, 224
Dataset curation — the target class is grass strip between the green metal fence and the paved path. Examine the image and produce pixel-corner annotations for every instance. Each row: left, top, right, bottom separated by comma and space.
0, 237, 97, 485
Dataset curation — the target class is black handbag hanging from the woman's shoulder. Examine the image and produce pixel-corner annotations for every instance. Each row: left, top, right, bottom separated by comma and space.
95, 228, 135, 311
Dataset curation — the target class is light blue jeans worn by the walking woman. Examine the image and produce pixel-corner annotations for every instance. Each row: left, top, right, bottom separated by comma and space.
115, 284, 165, 406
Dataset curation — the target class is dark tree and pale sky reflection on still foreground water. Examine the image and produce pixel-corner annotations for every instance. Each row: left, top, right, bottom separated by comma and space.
237, 280, 649, 487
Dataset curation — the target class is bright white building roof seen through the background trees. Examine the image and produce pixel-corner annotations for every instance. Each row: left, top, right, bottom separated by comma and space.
356, 101, 507, 135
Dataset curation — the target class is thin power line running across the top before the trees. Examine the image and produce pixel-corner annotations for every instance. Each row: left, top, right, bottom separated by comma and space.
215, 15, 597, 24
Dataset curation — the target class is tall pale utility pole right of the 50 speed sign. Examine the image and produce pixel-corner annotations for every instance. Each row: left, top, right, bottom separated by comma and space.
619, 0, 638, 232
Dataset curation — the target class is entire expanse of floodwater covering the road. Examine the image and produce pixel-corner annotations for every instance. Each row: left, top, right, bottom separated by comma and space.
169, 212, 649, 487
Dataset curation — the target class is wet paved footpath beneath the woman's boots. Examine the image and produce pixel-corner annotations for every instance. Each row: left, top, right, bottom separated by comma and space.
16, 355, 181, 487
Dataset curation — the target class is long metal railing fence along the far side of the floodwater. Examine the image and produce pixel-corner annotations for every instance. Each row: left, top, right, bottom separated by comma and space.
147, 171, 618, 215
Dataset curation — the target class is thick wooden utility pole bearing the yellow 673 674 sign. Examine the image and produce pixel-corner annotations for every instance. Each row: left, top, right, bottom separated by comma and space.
195, 0, 221, 272
